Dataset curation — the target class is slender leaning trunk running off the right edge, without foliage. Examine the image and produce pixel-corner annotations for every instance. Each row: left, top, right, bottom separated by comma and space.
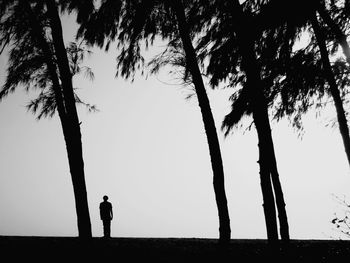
312, 14, 350, 168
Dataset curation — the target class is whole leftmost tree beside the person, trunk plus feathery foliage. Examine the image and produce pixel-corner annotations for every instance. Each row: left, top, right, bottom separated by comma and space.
0, 0, 91, 238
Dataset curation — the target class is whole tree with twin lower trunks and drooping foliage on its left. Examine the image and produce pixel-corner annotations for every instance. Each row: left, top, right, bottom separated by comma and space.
191, 1, 289, 243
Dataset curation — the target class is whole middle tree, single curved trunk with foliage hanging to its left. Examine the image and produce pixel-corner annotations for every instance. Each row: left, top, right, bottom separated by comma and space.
79, 0, 231, 243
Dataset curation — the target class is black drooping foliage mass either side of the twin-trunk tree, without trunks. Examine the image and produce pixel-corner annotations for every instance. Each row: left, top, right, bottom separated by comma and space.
189, 0, 349, 135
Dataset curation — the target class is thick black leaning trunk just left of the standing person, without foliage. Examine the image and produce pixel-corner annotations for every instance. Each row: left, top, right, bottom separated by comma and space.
46, 0, 92, 238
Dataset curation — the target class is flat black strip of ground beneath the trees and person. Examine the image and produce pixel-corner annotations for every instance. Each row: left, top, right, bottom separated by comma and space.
0, 236, 350, 263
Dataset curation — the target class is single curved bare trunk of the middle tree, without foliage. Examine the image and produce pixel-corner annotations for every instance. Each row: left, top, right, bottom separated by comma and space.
171, 0, 231, 244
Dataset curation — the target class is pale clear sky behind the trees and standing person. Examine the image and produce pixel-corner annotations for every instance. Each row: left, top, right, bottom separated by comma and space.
0, 11, 350, 239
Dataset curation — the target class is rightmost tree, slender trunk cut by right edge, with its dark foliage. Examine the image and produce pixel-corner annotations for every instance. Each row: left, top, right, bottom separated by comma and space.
235, 0, 350, 241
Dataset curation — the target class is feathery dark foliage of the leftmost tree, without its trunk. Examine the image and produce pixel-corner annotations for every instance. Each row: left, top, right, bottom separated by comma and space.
0, 1, 96, 119
